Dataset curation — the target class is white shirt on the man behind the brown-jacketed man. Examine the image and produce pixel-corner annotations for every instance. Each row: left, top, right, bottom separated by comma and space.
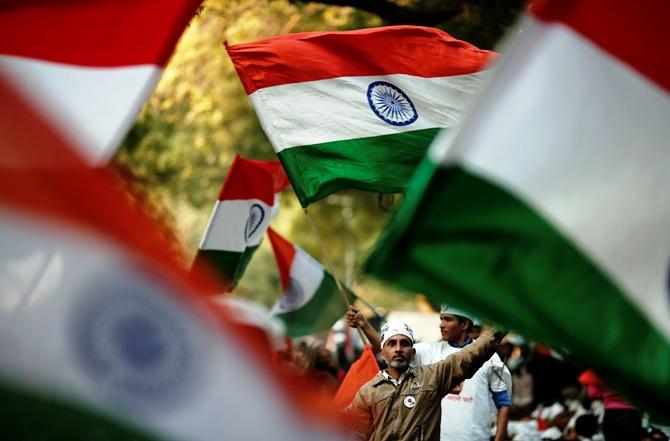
412, 341, 512, 441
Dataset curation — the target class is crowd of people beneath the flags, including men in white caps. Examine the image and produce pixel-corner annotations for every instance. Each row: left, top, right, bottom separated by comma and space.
268, 305, 670, 441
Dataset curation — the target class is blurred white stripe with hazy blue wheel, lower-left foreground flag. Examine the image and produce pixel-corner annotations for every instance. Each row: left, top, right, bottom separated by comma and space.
0, 212, 344, 441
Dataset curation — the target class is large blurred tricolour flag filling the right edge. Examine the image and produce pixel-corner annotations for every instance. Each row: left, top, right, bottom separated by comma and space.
368, 0, 670, 410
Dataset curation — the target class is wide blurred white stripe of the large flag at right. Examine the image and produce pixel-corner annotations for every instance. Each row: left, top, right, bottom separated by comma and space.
435, 19, 670, 338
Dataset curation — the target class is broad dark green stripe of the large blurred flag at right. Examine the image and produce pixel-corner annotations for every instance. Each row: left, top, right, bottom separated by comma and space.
366, 160, 670, 411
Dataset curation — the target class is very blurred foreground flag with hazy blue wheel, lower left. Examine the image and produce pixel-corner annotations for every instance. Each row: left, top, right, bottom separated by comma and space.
0, 77, 346, 441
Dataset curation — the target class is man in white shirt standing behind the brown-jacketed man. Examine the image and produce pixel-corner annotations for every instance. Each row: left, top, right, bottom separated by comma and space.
346, 306, 512, 441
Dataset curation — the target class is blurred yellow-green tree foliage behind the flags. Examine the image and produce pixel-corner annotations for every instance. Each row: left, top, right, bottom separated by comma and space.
116, 0, 523, 309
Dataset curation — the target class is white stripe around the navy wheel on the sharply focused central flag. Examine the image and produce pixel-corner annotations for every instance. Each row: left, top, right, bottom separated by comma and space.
249, 71, 488, 153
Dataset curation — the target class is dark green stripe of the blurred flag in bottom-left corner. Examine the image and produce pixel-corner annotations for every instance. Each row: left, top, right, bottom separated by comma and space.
0, 383, 165, 441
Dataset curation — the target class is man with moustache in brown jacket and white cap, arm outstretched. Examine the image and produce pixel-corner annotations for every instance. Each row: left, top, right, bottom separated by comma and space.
352, 321, 504, 441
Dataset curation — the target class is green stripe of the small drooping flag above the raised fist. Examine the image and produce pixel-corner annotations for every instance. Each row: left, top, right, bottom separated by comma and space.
277, 273, 356, 337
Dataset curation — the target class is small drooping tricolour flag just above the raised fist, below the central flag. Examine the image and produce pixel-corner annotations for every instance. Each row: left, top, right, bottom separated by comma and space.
268, 228, 356, 337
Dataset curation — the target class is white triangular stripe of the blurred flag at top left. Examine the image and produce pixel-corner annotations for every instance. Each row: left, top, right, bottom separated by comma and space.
0, 55, 162, 164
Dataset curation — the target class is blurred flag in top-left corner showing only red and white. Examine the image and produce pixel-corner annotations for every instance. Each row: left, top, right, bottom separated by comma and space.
0, 0, 200, 164
